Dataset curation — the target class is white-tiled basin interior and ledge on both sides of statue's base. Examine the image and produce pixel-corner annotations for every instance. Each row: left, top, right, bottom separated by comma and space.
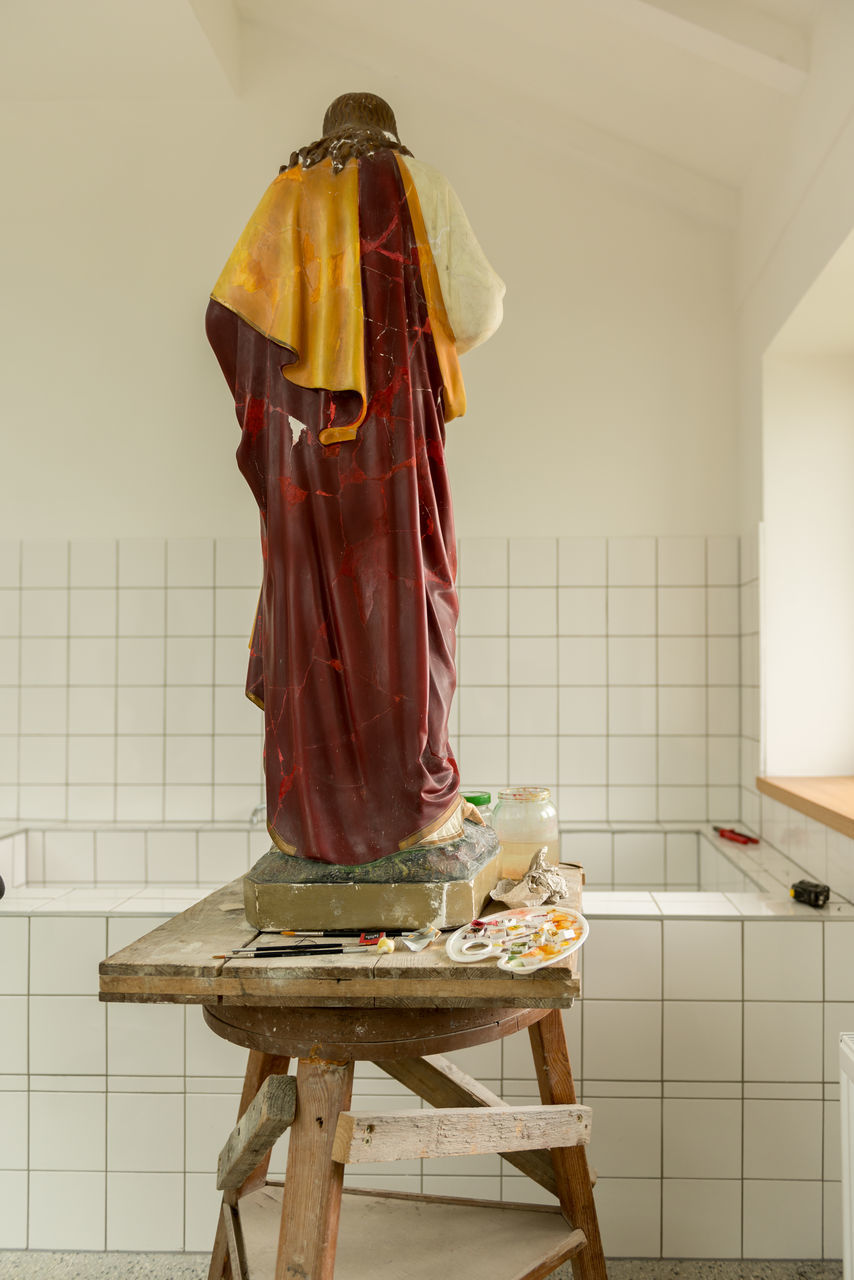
0, 819, 839, 901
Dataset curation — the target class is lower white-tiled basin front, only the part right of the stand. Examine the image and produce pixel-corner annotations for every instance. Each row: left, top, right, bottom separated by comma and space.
581, 920, 854, 1258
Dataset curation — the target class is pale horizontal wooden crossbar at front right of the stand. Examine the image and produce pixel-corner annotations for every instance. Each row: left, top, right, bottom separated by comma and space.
332, 1105, 590, 1165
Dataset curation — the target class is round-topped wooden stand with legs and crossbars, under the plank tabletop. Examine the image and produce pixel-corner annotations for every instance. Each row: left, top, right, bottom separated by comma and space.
205, 1007, 607, 1280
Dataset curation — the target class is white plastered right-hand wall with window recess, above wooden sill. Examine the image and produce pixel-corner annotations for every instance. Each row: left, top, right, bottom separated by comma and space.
736, 0, 854, 773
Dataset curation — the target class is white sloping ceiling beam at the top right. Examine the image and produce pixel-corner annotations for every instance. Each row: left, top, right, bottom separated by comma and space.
593, 0, 809, 93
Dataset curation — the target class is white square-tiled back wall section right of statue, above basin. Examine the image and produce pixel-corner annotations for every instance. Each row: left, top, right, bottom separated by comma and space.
458, 538, 740, 822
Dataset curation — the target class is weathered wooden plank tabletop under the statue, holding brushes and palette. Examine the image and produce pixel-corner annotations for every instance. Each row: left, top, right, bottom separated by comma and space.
100, 867, 581, 1009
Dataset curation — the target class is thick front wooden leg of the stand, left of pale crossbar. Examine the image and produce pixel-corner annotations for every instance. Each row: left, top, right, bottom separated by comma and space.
275, 1057, 353, 1280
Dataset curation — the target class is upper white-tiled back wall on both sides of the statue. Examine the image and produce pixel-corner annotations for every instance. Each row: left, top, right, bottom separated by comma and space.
0, 538, 744, 822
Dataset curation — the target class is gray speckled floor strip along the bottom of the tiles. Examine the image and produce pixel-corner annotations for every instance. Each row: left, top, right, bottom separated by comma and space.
0, 1252, 842, 1280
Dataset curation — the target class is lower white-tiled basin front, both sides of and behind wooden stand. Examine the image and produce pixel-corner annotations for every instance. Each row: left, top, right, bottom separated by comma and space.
0, 913, 854, 1258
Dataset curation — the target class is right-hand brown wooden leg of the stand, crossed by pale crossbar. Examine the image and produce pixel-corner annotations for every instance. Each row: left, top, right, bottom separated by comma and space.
528, 1009, 608, 1280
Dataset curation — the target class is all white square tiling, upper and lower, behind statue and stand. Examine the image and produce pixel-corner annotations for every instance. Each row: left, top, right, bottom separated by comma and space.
10, 524, 854, 1258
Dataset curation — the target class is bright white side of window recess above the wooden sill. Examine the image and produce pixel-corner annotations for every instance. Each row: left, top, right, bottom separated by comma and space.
763, 352, 854, 774
